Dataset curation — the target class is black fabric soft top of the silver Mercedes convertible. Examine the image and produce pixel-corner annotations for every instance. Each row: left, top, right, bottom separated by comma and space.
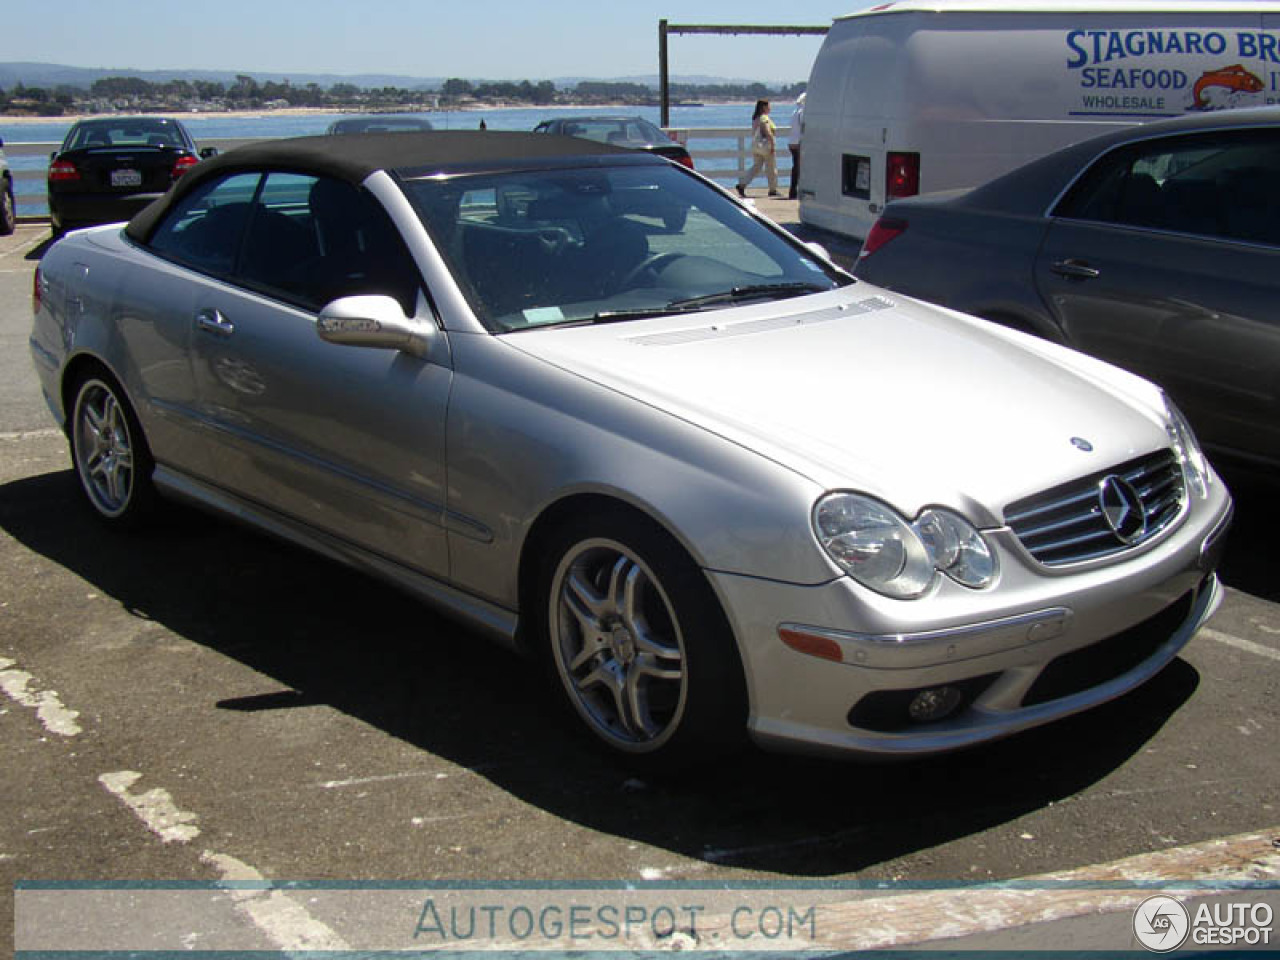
125, 131, 645, 242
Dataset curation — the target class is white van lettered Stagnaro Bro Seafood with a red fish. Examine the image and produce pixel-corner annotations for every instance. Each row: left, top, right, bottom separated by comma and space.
799, 0, 1280, 239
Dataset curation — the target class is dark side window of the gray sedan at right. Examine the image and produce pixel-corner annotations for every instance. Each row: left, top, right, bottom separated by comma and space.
1055, 129, 1280, 246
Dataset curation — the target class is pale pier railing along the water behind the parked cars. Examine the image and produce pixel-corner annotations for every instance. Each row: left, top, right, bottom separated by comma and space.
4, 127, 791, 220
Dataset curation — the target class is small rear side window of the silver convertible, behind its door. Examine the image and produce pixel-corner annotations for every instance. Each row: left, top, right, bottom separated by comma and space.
148, 173, 261, 276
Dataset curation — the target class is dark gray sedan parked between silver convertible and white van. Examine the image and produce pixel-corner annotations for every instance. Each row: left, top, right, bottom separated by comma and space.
855, 108, 1280, 466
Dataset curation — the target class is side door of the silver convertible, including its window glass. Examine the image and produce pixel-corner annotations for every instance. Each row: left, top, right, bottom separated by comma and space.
180, 173, 452, 576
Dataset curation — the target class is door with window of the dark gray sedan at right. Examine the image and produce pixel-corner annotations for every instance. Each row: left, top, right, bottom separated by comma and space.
1034, 129, 1280, 461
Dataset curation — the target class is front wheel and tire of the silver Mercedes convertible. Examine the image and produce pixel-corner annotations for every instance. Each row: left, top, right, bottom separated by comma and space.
544, 518, 745, 767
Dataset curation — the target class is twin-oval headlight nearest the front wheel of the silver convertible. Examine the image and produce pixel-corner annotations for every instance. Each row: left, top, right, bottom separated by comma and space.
813, 493, 996, 599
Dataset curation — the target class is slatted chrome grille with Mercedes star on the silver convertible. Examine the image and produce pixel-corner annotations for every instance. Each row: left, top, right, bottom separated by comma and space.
1005, 449, 1184, 567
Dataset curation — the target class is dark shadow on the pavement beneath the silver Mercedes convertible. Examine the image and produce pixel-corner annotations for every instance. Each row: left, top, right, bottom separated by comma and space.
0, 470, 1199, 877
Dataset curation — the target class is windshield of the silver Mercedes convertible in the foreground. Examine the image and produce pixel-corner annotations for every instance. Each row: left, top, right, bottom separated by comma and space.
394, 164, 851, 333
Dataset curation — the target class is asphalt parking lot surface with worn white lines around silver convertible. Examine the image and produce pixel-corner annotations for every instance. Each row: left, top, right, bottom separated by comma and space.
0, 225, 1280, 957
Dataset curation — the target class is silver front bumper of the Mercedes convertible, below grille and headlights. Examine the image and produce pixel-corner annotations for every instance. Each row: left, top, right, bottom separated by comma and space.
709, 481, 1231, 756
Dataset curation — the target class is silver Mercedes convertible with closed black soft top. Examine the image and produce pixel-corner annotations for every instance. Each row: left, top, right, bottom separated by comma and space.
31, 132, 1231, 765
